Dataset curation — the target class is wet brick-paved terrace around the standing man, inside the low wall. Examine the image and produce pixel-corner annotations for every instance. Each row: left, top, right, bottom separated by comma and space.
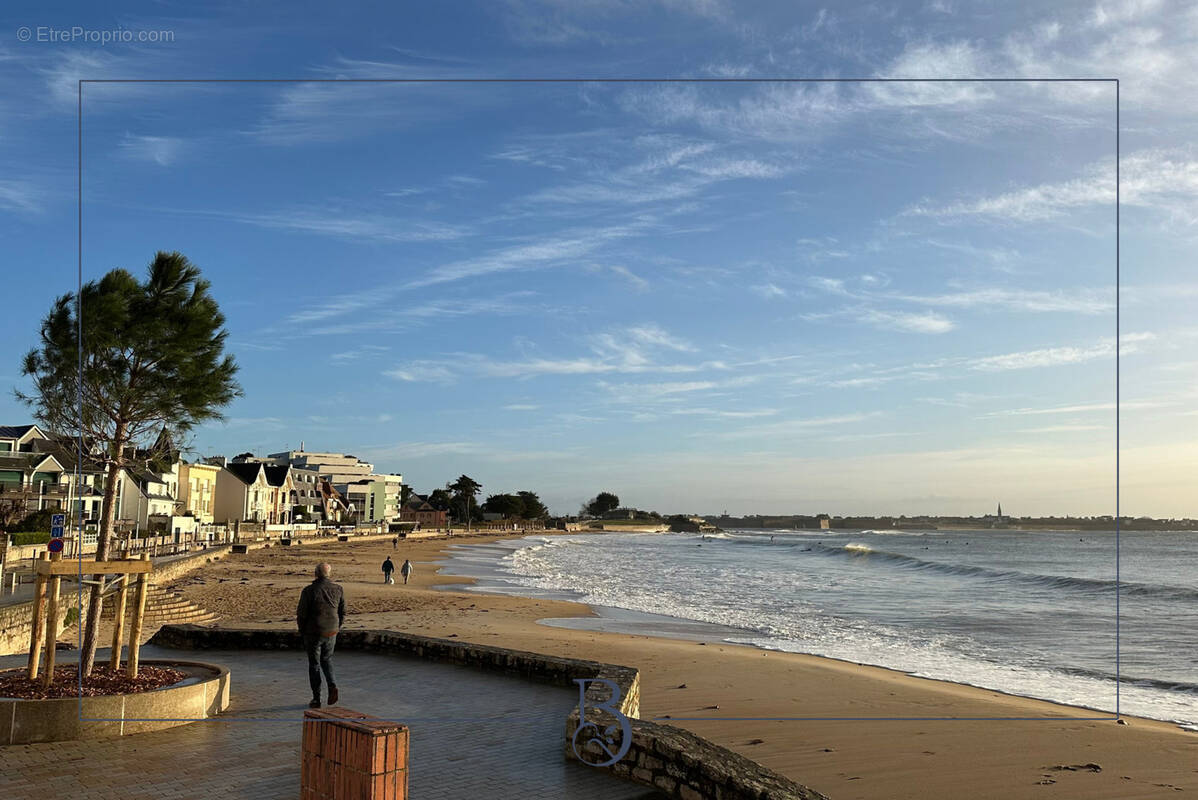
0, 647, 660, 800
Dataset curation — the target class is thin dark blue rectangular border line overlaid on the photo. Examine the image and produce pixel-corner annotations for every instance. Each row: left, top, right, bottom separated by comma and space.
75, 78, 1123, 722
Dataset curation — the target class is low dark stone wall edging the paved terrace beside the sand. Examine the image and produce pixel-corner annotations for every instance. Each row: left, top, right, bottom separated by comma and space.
150, 625, 828, 800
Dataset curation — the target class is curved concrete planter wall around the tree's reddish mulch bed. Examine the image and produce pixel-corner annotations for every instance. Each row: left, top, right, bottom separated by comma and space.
0, 660, 229, 745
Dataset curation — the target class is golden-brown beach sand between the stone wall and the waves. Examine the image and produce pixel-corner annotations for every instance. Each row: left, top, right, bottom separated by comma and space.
174, 534, 1198, 800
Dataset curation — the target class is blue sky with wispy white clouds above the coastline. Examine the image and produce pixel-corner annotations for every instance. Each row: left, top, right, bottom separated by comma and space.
0, 0, 1198, 517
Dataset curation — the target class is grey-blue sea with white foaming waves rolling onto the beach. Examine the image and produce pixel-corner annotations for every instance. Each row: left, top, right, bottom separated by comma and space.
441, 529, 1198, 731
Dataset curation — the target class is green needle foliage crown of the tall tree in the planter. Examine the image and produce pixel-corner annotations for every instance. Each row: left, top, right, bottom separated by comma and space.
17, 253, 241, 461
